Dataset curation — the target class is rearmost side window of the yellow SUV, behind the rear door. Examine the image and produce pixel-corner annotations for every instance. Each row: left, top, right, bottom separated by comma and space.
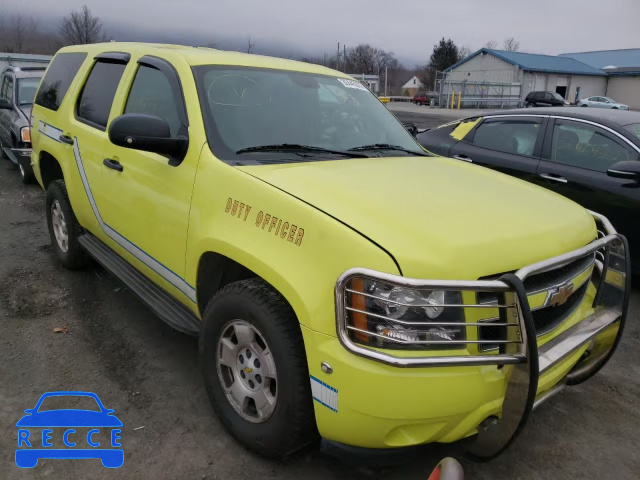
36, 53, 87, 110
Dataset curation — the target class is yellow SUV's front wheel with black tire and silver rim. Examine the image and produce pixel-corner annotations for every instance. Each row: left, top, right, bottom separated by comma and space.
199, 279, 317, 458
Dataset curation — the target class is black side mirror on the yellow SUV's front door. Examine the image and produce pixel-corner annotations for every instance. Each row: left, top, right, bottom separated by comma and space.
109, 113, 189, 159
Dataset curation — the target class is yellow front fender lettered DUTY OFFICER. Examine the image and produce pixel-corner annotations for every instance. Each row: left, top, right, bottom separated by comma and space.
186, 152, 399, 336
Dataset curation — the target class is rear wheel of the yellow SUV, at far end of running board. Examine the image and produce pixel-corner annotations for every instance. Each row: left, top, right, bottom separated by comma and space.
46, 180, 89, 270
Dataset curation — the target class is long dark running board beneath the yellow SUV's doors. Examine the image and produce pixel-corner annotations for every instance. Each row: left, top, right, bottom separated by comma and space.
78, 233, 200, 336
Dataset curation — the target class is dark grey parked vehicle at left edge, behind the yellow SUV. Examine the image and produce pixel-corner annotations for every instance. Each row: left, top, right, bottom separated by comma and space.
0, 67, 46, 183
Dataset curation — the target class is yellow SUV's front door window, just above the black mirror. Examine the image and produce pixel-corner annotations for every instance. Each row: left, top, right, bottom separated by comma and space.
124, 65, 181, 137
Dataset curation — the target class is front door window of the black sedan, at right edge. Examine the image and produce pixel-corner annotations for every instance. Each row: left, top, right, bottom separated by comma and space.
550, 121, 636, 172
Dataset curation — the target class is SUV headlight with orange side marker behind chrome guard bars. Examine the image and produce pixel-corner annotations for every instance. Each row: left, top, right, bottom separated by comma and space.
345, 277, 465, 350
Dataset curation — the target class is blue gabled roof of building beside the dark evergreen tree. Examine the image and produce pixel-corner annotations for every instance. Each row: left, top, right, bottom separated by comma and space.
445, 48, 606, 76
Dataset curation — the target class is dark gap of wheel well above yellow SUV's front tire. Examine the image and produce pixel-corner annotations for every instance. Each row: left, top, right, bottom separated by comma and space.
196, 252, 260, 315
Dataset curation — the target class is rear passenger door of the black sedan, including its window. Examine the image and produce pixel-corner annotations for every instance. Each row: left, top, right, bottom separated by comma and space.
451, 116, 546, 181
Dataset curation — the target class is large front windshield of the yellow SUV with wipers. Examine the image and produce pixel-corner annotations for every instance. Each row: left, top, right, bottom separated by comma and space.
194, 65, 424, 163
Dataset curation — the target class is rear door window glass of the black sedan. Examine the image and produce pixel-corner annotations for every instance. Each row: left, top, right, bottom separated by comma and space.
473, 118, 542, 157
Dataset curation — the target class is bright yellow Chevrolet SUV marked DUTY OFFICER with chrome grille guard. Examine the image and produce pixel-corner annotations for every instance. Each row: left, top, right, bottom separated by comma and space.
31, 43, 629, 457
